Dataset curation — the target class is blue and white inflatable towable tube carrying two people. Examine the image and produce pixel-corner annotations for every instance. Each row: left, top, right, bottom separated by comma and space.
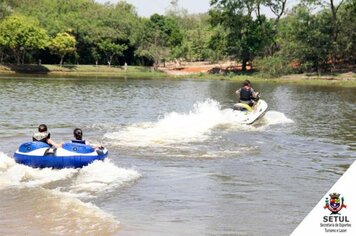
14, 141, 108, 169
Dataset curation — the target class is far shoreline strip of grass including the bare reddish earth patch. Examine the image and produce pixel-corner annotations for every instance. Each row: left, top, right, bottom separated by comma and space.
0, 62, 356, 87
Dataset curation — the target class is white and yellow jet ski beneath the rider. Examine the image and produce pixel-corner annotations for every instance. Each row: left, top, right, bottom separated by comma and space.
233, 96, 268, 125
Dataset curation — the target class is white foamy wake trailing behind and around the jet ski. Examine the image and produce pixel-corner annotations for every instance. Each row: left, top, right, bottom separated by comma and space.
104, 99, 293, 146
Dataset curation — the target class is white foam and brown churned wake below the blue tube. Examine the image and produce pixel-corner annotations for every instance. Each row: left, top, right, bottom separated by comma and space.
0, 152, 141, 235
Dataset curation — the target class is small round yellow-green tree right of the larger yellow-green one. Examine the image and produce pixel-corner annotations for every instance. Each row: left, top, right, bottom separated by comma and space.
49, 33, 76, 66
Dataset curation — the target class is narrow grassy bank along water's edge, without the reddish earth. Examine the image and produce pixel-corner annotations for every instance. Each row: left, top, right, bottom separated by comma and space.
0, 65, 356, 87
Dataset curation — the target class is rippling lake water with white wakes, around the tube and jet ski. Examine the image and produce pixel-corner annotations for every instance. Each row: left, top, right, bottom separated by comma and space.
0, 77, 356, 235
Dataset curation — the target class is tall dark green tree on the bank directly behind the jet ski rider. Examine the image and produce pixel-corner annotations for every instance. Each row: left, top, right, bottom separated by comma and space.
210, 0, 274, 71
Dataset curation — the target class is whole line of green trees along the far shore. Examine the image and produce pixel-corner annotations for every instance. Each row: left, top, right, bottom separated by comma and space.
0, 0, 356, 75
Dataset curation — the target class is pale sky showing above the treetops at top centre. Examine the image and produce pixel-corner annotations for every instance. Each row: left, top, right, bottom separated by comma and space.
96, 0, 210, 17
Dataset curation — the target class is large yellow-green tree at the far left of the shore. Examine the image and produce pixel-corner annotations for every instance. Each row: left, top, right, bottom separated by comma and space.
0, 14, 48, 64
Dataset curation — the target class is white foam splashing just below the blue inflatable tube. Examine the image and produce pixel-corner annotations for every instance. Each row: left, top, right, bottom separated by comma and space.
0, 153, 141, 198
